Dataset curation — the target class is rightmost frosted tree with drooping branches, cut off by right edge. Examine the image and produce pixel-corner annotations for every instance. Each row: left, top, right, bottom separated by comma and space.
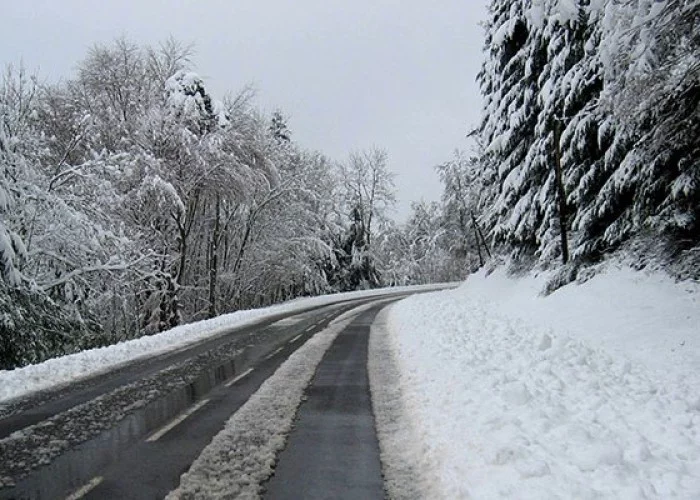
596, 0, 700, 248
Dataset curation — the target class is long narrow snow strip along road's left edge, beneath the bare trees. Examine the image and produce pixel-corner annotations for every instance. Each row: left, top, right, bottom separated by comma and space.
0, 283, 455, 403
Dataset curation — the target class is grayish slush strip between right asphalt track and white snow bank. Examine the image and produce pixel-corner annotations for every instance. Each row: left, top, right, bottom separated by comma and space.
367, 306, 433, 500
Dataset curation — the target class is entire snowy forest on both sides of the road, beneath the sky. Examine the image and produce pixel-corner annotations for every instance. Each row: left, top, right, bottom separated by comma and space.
0, 0, 700, 369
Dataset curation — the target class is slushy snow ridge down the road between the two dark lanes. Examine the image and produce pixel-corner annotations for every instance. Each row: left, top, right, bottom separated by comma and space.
166, 304, 380, 500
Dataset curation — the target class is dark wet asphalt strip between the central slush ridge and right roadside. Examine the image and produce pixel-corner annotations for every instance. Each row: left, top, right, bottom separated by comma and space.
265, 306, 385, 500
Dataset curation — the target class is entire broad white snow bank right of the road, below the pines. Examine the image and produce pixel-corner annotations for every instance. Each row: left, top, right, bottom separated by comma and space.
388, 269, 700, 499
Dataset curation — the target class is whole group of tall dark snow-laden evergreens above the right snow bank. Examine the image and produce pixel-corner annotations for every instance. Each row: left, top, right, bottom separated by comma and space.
442, 0, 700, 277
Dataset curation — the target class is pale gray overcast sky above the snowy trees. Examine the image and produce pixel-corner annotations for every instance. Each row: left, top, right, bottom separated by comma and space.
0, 0, 486, 219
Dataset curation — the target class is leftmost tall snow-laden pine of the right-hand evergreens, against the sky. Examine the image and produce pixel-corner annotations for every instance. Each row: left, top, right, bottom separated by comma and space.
478, 0, 546, 253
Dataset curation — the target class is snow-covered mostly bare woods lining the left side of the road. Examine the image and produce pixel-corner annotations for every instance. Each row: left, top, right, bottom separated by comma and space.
0, 40, 470, 368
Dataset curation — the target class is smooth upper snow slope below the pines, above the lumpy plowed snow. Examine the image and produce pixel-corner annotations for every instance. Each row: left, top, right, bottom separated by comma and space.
463, 263, 700, 387
